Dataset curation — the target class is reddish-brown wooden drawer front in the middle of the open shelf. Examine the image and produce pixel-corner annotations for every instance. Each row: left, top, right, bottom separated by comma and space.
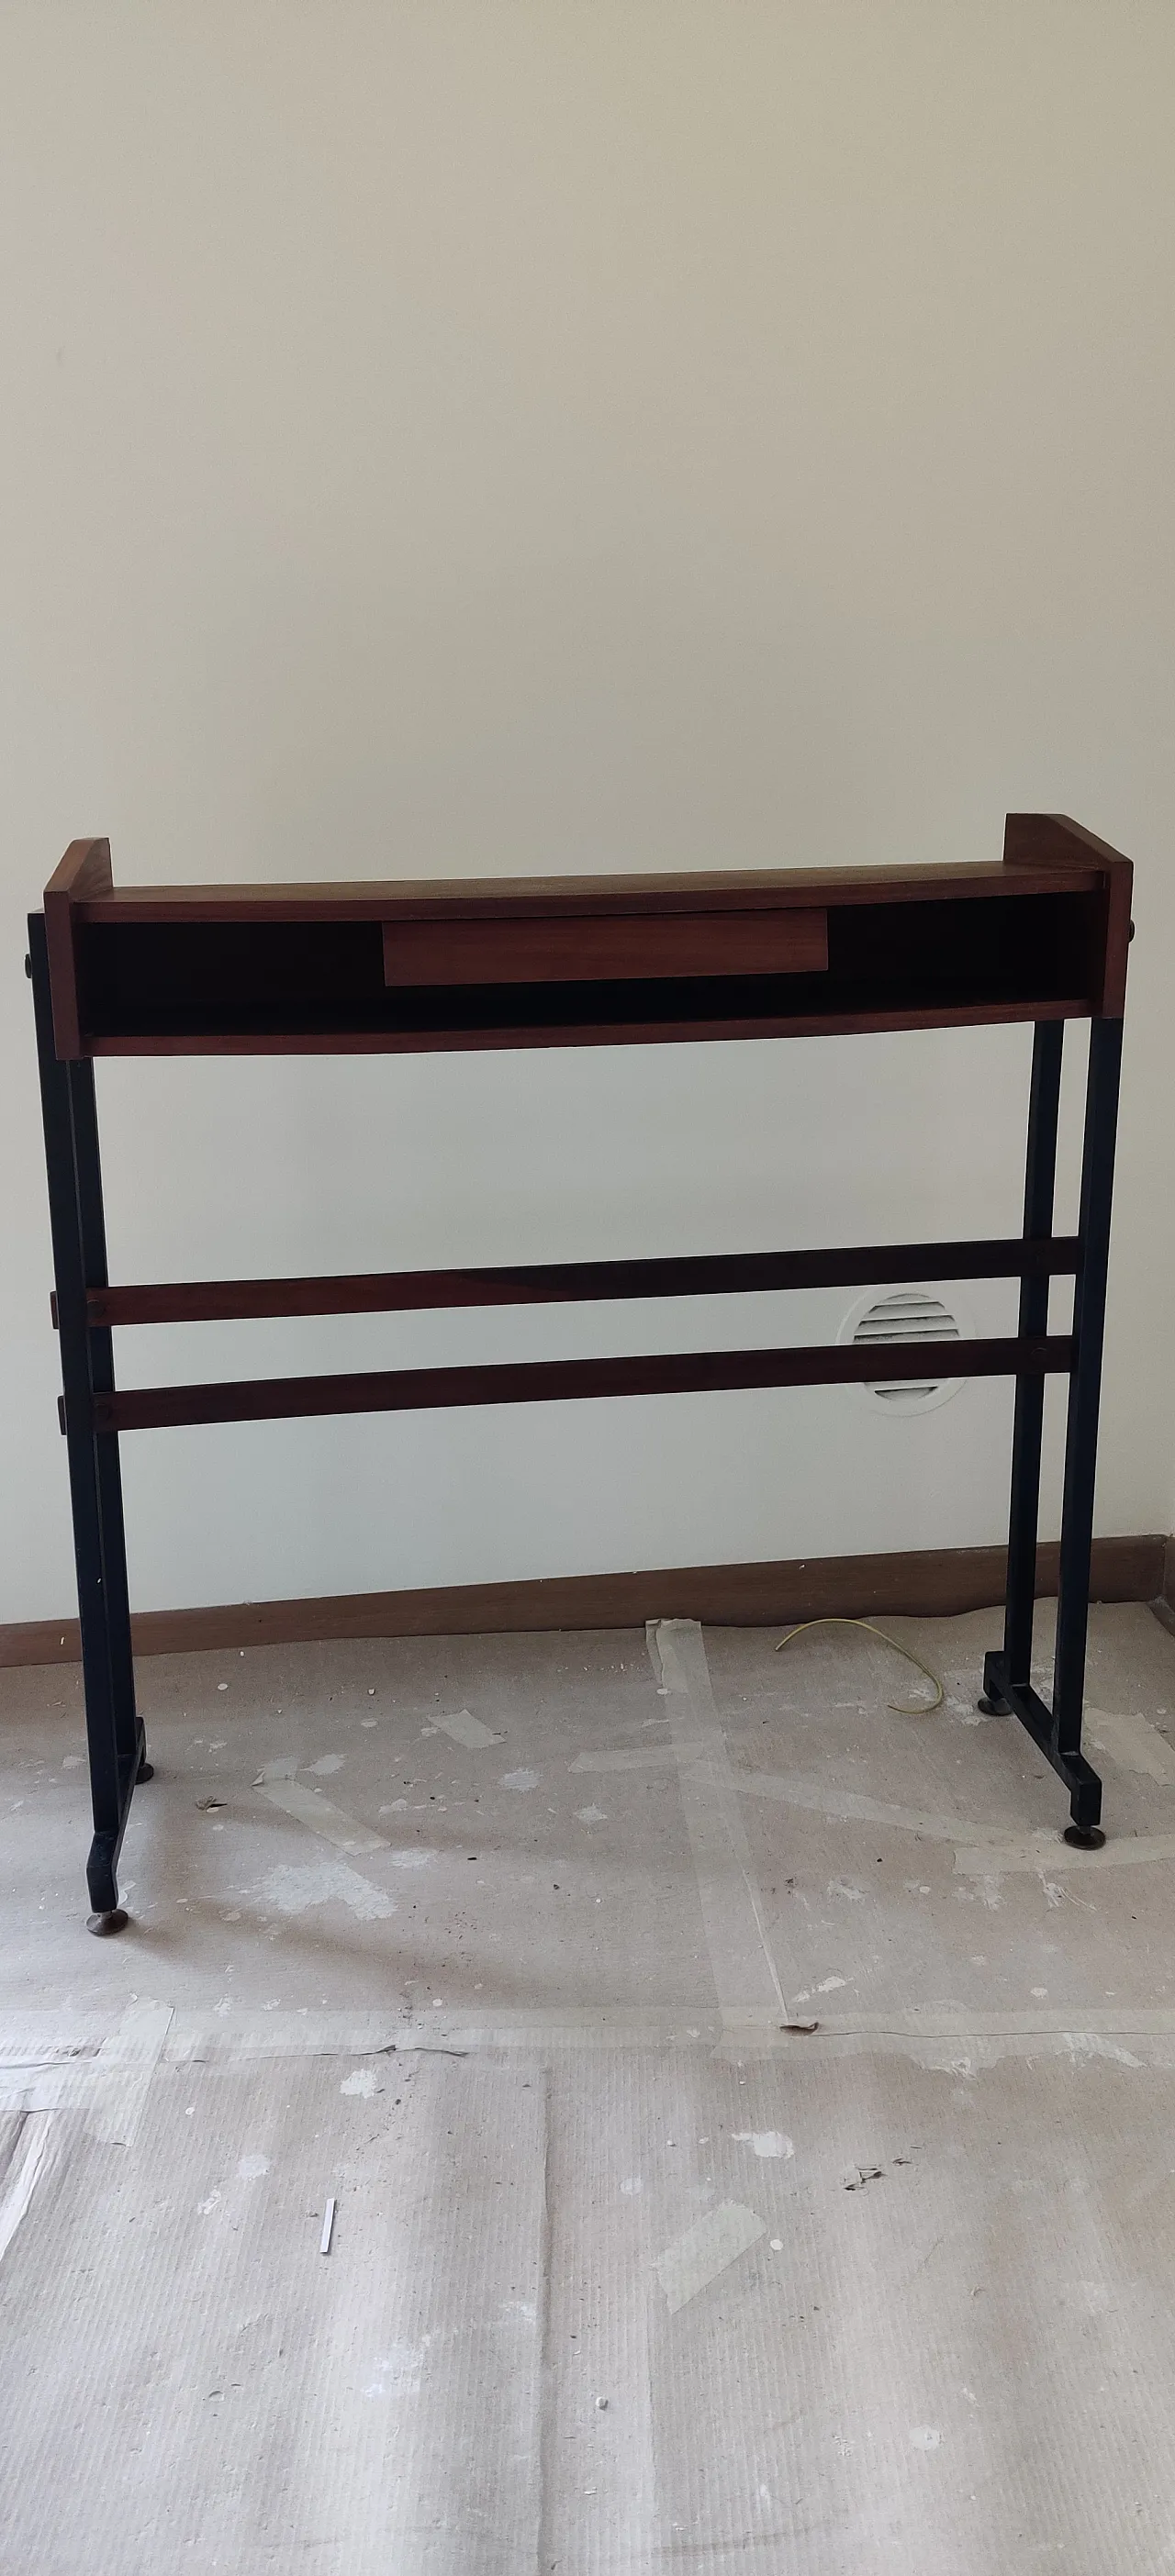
384, 909, 827, 984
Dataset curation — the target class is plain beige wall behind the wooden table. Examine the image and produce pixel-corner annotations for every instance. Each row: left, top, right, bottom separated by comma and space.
0, 0, 1175, 1618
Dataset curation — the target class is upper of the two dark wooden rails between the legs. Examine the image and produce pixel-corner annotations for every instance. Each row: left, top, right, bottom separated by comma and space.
73, 1234, 1080, 1327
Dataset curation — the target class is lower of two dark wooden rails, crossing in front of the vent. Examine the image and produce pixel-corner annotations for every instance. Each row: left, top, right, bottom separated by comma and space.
82, 1334, 1075, 1433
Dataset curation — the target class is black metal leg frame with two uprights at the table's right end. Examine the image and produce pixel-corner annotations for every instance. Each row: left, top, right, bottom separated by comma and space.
984, 1020, 1121, 1847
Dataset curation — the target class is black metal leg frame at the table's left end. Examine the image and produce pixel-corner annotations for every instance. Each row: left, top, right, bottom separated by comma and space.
28, 914, 150, 1932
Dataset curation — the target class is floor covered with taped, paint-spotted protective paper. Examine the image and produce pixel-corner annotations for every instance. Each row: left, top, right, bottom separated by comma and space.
0, 1605, 1175, 2576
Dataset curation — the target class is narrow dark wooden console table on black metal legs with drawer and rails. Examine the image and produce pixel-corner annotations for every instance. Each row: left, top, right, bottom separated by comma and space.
28, 814, 1131, 1932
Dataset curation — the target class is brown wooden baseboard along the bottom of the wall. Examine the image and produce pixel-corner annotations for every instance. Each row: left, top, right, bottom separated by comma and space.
0, 1535, 1175, 1664
